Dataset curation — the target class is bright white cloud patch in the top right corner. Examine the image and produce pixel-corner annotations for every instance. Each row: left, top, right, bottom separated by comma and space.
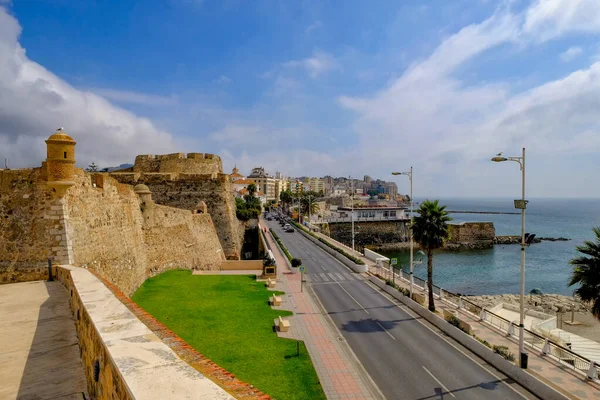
523, 0, 600, 41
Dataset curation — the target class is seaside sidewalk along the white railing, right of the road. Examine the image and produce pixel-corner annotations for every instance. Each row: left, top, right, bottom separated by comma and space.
370, 257, 600, 399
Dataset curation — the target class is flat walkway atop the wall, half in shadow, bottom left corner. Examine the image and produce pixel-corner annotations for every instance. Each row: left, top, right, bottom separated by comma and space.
0, 281, 89, 399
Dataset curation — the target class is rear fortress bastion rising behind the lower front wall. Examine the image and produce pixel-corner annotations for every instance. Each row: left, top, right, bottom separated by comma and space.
110, 153, 244, 260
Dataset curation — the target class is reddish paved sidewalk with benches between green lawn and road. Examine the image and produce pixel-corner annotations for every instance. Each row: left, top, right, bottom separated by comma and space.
263, 222, 383, 400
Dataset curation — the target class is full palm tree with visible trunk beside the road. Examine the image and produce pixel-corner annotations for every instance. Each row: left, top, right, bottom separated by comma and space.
411, 200, 452, 311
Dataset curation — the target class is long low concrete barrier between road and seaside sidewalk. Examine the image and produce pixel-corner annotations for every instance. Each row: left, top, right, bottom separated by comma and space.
369, 276, 568, 400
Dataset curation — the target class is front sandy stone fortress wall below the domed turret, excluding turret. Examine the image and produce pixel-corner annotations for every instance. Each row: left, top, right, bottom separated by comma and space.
0, 168, 225, 295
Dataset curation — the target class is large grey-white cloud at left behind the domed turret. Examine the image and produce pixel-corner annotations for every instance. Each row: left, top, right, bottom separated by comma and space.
0, 7, 174, 168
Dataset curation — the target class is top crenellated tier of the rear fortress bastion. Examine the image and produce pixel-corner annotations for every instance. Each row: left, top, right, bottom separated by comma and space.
133, 153, 223, 174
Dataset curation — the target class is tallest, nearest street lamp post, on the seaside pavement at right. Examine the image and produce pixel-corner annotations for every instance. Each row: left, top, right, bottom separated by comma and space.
492, 147, 528, 368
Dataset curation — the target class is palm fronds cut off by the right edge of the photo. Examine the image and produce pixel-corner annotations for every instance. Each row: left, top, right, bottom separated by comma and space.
569, 226, 600, 320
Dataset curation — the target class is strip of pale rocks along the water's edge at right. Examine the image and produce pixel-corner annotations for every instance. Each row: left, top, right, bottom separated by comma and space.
465, 294, 591, 315
